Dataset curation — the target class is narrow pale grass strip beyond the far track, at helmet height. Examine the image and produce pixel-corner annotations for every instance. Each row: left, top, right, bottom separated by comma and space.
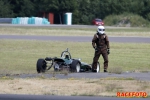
0, 26, 150, 37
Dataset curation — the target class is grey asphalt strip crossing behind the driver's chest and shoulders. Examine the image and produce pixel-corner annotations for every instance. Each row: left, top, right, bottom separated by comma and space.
0, 35, 150, 43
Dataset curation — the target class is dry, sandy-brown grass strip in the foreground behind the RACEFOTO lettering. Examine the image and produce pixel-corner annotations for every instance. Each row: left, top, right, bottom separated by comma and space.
0, 78, 150, 96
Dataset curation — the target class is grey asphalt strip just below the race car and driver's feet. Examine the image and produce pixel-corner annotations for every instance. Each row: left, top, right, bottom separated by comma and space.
6, 72, 150, 81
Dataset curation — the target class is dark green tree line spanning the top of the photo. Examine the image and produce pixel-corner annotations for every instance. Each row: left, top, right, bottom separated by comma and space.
0, 0, 150, 24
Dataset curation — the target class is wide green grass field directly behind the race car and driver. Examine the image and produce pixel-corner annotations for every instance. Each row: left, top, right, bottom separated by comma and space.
0, 39, 150, 74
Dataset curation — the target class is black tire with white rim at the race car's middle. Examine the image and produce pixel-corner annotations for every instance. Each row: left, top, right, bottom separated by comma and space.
70, 60, 81, 73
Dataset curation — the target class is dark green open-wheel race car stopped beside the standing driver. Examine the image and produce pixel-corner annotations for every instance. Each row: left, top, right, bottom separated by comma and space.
36, 48, 100, 73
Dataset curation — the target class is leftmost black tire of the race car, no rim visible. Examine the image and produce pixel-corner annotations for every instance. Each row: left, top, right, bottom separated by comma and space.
36, 59, 46, 73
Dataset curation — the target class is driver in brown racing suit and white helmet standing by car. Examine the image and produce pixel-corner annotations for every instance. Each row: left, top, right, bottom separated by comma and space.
92, 26, 110, 72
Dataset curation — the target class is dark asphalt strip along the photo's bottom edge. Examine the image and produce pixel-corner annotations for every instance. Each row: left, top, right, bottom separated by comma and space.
0, 94, 149, 100
